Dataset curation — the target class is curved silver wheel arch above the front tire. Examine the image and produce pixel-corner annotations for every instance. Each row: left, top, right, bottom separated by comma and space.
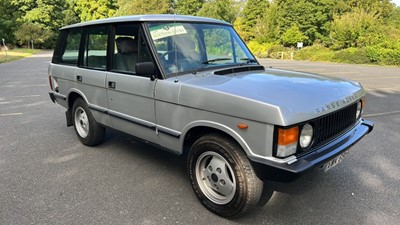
182, 121, 251, 155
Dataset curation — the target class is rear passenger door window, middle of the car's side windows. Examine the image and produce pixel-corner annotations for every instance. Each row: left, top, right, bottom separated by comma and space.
83, 26, 109, 70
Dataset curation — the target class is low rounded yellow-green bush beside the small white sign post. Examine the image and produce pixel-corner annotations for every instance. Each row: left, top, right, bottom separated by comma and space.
294, 44, 334, 61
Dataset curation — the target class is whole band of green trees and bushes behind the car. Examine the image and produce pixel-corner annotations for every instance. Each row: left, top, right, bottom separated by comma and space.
0, 0, 400, 65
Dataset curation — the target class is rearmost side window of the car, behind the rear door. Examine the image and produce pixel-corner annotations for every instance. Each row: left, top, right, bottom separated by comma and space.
60, 30, 82, 65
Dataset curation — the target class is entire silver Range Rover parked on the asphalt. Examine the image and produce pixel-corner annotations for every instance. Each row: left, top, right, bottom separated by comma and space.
48, 15, 373, 217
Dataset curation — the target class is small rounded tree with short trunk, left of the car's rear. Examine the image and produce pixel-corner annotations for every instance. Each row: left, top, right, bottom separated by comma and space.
15, 22, 53, 48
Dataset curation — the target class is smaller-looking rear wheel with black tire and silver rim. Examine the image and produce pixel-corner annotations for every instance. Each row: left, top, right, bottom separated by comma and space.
72, 98, 106, 146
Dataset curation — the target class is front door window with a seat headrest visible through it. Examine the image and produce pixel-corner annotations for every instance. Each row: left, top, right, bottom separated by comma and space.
113, 24, 139, 73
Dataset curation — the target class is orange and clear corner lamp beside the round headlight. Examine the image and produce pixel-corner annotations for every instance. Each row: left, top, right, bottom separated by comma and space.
276, 127, 299, 157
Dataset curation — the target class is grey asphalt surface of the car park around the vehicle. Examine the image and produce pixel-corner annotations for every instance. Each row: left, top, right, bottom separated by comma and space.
0, 53, 400, 225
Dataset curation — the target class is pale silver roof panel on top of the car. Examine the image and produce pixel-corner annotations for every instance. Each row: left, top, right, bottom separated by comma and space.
61, 14, 231, 29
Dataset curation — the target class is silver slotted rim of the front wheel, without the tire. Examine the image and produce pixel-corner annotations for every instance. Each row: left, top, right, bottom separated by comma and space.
195, 151, 236, 205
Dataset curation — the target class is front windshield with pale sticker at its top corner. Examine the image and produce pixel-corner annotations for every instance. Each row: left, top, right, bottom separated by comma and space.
148, 22, 257, 77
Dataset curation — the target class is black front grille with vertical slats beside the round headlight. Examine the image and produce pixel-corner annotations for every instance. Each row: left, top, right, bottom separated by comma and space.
312, 104, 357, 149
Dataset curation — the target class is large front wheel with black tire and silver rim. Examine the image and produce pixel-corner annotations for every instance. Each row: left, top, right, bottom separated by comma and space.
188, 133, 263, 218
